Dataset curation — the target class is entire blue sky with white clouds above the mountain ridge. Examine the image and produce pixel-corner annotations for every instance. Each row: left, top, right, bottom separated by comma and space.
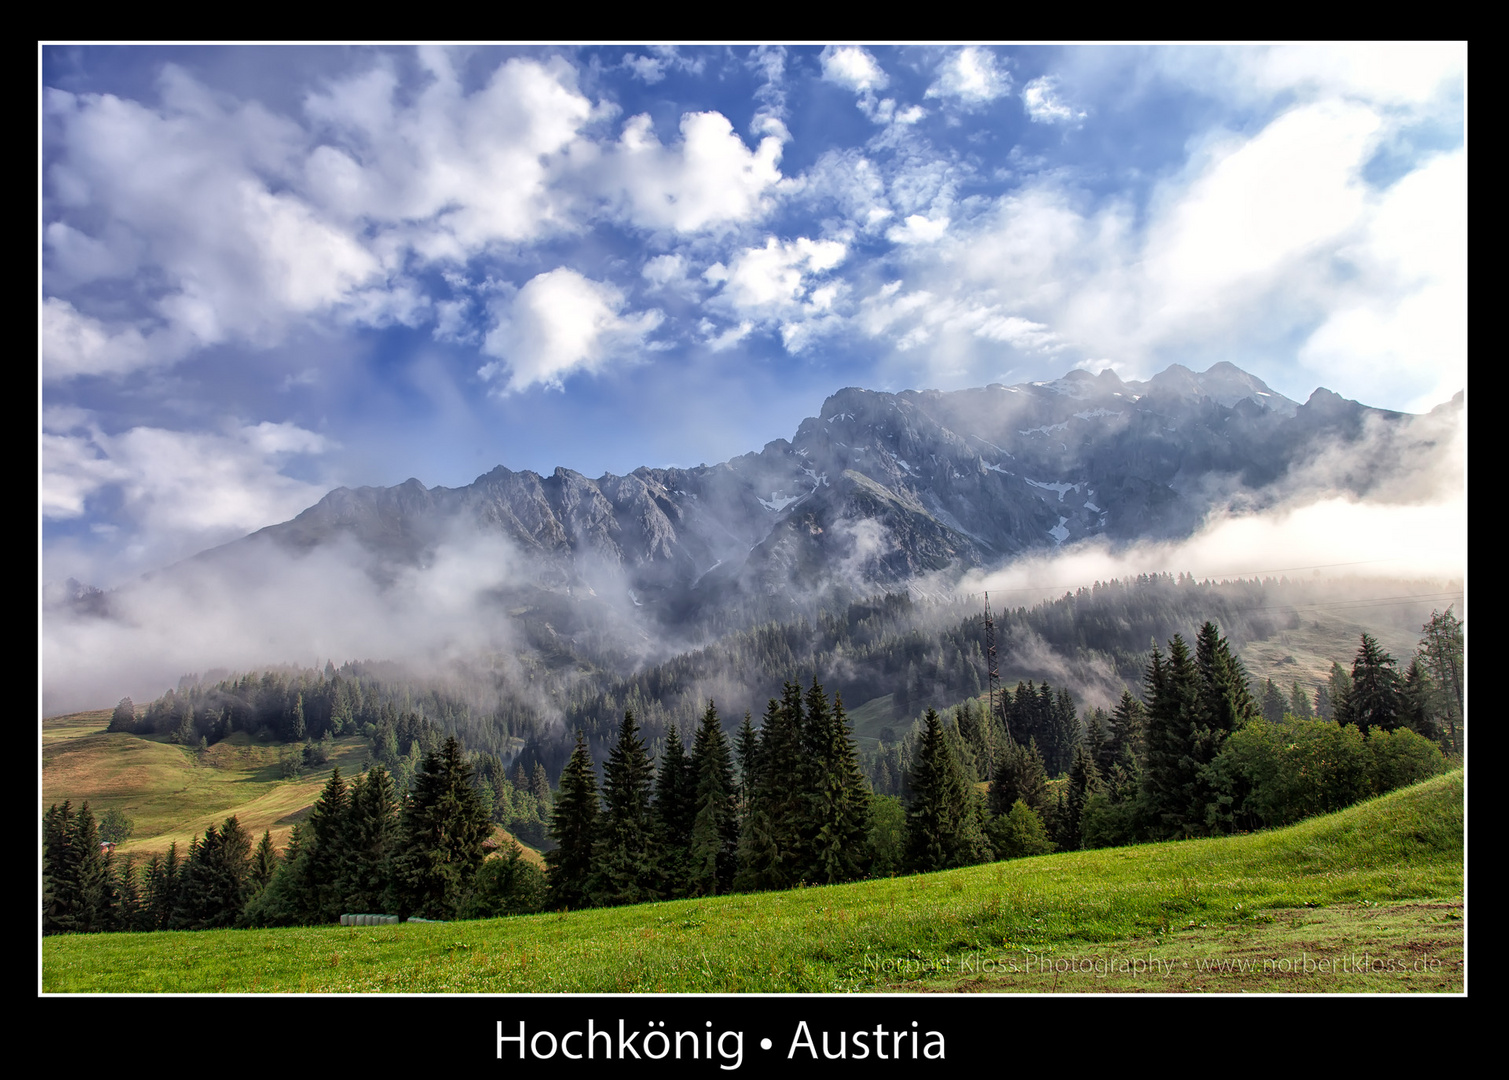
39, 44, 1467, 587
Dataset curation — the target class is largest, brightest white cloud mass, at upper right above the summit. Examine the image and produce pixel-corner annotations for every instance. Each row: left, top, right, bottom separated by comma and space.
859, 87, 1465, 407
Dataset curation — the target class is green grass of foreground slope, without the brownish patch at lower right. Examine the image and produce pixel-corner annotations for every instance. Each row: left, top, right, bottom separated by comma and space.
42, 772, 1464, 993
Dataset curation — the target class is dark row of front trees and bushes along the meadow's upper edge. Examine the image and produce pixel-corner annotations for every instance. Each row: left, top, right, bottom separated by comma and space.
44, 609, 1465, 932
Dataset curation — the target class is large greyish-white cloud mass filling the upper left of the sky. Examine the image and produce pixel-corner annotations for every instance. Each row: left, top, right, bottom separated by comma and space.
44, 50, 592, 380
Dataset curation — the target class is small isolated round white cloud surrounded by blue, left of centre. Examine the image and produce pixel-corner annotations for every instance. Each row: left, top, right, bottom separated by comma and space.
478, 267, 662, 394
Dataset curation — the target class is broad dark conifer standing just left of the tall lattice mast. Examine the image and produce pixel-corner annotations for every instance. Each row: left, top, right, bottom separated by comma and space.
907, 709, 990, 872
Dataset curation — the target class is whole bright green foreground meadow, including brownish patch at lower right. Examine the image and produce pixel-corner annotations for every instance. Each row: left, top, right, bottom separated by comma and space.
42, 772, 1465, 994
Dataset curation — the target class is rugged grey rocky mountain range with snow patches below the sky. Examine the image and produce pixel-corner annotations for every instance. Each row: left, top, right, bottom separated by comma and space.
168, 362, 1462, 633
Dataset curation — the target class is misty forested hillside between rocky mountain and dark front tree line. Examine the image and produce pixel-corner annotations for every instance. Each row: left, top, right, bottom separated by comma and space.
111, 575, 1453, 780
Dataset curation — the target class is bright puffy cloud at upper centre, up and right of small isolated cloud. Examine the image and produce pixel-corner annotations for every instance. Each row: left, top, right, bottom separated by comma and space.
602, 113, 782, 232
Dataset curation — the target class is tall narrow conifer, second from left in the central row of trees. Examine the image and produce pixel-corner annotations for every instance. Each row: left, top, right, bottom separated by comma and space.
592, 710, 661, 905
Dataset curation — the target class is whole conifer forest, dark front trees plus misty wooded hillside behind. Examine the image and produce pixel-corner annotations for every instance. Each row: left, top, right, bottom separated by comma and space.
42, 578, 1465, 934
